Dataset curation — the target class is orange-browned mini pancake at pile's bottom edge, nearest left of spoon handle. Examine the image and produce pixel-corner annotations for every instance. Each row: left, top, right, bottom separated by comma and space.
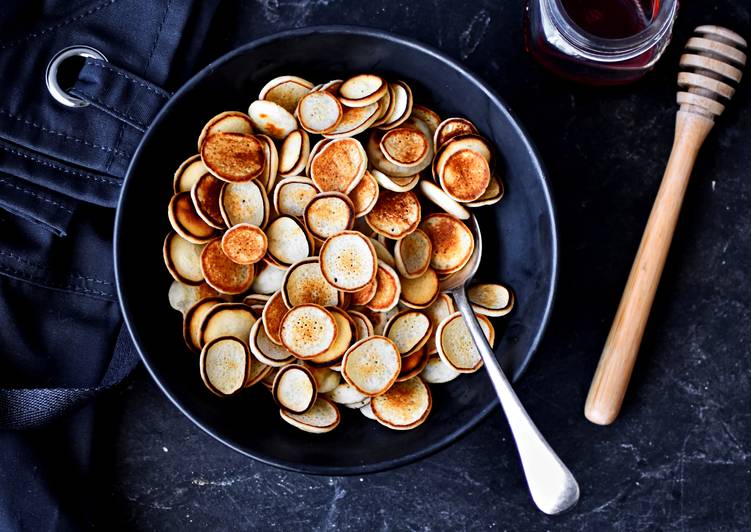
370, 377, 433, 430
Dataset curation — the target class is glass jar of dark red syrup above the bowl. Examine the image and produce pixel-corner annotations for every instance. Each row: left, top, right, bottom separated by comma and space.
524, 0, 678, 85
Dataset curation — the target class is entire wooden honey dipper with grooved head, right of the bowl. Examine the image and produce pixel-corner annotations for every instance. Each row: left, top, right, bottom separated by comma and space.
584, 26, 746, 425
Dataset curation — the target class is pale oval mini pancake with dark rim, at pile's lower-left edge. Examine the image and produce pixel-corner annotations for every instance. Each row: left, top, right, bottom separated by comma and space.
200, 338, 250, 397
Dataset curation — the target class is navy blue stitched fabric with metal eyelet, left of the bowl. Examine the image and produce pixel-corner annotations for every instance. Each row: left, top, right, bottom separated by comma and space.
0, 0, 218, 531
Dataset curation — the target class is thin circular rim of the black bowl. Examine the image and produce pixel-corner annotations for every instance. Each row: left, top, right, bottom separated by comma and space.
113, 25, 559, 476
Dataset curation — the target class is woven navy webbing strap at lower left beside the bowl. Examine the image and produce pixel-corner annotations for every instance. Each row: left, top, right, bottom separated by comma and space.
0, 325, 139, 430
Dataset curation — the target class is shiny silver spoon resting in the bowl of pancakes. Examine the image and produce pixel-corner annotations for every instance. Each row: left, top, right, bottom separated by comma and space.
441, 215, 579, 514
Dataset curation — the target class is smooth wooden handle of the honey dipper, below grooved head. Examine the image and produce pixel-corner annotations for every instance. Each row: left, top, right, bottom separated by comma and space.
584, 110, 714, 425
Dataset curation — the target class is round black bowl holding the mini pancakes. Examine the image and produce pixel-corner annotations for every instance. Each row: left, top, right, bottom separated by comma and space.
115, 27, 557, 475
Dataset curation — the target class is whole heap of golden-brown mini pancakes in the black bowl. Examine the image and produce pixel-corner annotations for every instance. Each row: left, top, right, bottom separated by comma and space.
164, 74, 514, 433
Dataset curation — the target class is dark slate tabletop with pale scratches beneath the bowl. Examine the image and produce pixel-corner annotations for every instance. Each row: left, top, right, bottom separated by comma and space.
96, 0, 751, 531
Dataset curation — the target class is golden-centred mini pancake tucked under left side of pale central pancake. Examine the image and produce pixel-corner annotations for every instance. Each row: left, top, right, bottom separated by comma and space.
282, 257, 342, 308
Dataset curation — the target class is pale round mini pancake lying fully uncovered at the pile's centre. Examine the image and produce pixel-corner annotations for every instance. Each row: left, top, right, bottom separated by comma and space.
319, 231, 378, 292
